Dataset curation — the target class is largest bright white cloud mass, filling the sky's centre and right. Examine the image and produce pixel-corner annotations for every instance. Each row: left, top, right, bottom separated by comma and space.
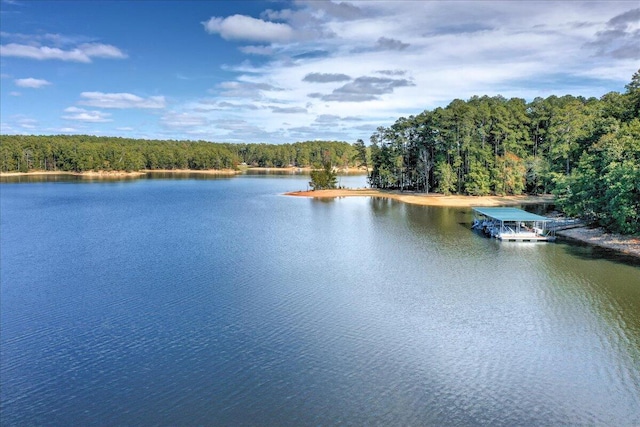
191, 1, 637, 145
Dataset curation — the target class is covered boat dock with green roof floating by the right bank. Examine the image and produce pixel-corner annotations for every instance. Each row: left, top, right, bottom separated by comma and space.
471, 207, 556, 242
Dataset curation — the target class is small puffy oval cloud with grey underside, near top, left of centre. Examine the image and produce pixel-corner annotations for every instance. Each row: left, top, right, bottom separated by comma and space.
202, 15, 293, 42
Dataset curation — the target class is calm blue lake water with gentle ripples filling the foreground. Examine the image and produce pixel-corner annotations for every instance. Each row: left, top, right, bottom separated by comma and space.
0, 175, 640, 427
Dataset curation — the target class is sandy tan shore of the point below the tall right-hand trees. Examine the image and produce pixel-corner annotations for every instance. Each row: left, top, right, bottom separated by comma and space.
286, 188, 553, 207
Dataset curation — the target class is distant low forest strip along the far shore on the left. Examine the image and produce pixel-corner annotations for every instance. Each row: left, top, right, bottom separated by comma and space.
0, 135, 357, 172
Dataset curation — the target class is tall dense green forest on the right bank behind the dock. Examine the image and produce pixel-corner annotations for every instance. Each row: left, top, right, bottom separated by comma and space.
369, 70, 640, 233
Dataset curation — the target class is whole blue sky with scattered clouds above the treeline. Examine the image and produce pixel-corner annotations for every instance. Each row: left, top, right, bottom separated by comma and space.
0, 0, 640, 143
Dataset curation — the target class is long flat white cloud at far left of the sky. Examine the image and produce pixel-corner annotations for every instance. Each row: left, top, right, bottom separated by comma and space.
0, 43, 127, 63
